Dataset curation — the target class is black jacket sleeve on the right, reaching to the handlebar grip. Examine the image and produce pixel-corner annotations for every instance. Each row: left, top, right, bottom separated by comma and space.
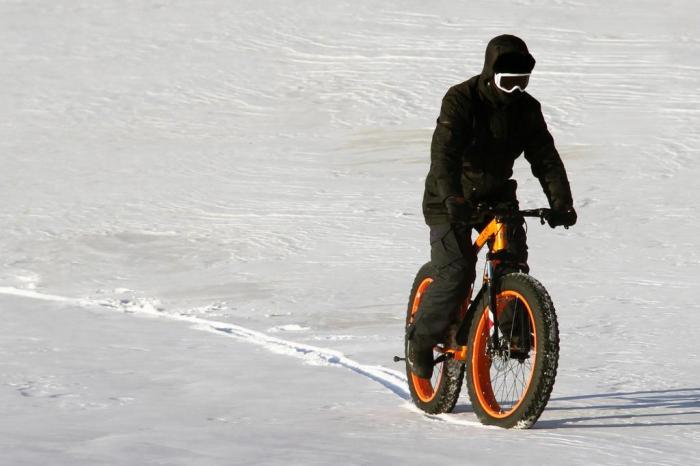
525, 102, 573, 210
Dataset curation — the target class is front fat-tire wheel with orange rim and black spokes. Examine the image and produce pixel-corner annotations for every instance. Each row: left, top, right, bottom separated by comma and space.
467, 273, 559, 429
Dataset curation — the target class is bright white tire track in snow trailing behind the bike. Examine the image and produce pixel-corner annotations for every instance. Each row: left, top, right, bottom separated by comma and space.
0, 286, 489, 428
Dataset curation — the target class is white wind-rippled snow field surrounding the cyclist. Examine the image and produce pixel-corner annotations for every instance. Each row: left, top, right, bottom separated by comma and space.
0, 0, 700, 465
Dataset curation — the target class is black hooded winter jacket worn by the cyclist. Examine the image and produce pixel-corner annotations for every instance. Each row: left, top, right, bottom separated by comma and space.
423, 35, 573, 225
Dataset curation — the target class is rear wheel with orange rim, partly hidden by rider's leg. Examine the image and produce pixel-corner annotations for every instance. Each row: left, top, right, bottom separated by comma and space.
404, 263, 464, 414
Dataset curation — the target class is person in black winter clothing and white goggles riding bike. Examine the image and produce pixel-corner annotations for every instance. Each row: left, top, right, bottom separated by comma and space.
407, 35, 577, 378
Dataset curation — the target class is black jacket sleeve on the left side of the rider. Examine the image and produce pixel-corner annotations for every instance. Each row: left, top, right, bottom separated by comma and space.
430, 89, 471, 202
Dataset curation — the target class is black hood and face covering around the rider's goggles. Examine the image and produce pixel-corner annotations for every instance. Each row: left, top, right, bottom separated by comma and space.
479, 34, 535, 106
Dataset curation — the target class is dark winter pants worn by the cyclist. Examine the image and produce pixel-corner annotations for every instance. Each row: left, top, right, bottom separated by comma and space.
411, 187, 527, 345
